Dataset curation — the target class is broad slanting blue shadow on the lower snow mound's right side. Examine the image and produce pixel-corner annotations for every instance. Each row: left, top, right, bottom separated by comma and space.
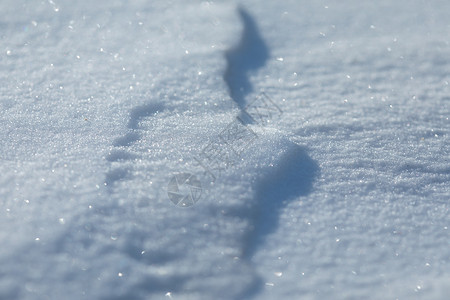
243, 144, 319, 259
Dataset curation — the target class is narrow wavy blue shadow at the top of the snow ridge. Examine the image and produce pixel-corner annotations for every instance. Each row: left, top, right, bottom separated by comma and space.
223, 8, 269, 109
